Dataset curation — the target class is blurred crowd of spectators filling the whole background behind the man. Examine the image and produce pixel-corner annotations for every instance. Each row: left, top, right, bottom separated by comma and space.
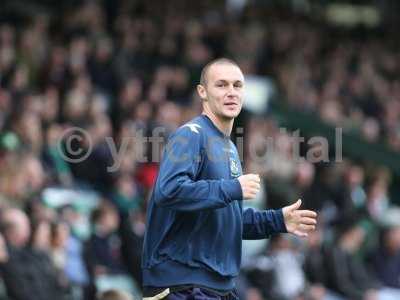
0, 0, 400, 300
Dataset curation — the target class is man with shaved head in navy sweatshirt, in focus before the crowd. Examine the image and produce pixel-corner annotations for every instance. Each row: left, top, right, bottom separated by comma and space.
142, 58, 316, 299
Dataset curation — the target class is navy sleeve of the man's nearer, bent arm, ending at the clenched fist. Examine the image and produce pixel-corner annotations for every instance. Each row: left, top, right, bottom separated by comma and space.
155, 127, 242, 211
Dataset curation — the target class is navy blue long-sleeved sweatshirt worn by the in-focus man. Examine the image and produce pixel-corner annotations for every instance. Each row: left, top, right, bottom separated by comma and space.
142, 115, 286, 290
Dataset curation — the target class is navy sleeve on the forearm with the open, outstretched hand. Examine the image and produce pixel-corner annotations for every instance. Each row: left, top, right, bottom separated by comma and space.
242, 208, 287, 240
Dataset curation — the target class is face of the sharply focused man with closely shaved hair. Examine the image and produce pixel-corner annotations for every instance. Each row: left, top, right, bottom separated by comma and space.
198, 63, 244, 120
